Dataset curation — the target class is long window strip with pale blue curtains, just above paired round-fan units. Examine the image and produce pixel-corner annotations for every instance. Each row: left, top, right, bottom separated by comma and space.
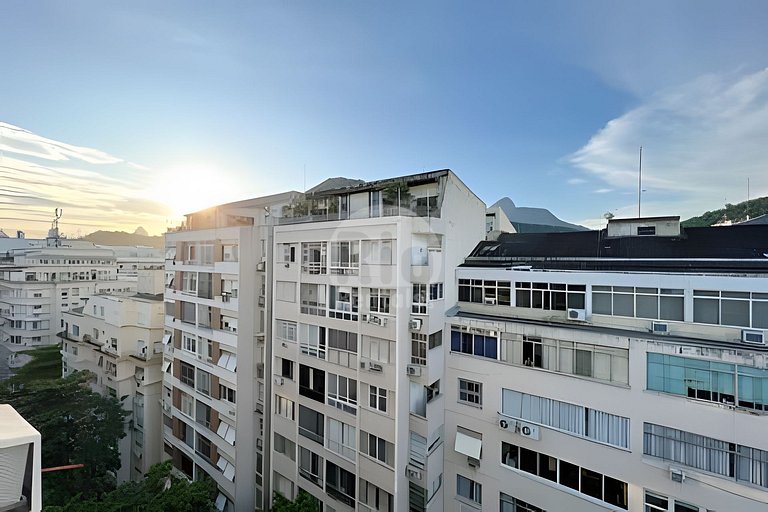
501, 388, 629, 448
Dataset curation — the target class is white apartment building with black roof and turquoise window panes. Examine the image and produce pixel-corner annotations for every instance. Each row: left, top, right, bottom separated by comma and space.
443, 218, 768, 512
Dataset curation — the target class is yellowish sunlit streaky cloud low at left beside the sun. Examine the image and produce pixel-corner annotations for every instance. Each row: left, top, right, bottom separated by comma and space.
0, 123, 169, 236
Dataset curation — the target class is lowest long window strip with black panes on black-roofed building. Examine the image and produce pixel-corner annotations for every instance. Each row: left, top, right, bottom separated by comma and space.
501, 441, 629, 510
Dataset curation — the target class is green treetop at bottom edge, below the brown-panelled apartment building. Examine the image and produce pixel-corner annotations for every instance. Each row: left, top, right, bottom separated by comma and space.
44, 461, 216, 512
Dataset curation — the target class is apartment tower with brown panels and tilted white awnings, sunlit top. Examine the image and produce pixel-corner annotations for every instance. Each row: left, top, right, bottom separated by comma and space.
162, 193, 297, 511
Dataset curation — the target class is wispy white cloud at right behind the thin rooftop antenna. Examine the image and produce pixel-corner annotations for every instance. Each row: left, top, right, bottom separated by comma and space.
569, 69, 768, 216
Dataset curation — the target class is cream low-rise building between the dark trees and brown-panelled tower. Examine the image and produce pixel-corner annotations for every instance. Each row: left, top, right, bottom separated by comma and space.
60, 266, 165, 482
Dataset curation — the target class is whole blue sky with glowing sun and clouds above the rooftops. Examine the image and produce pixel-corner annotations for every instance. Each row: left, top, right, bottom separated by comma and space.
0, 0, 768, 236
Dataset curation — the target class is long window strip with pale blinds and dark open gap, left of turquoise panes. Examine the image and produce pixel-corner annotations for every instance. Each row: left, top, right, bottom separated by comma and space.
508, 336, 629, 384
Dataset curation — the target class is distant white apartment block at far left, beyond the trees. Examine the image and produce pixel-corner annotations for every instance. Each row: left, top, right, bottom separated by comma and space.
0, 230, 163, 346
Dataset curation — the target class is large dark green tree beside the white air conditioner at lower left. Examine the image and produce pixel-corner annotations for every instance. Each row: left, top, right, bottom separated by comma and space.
0, 347, 127, 504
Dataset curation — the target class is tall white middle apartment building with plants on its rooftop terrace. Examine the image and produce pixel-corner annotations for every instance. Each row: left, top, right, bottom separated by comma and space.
268, 170, 486, 511
